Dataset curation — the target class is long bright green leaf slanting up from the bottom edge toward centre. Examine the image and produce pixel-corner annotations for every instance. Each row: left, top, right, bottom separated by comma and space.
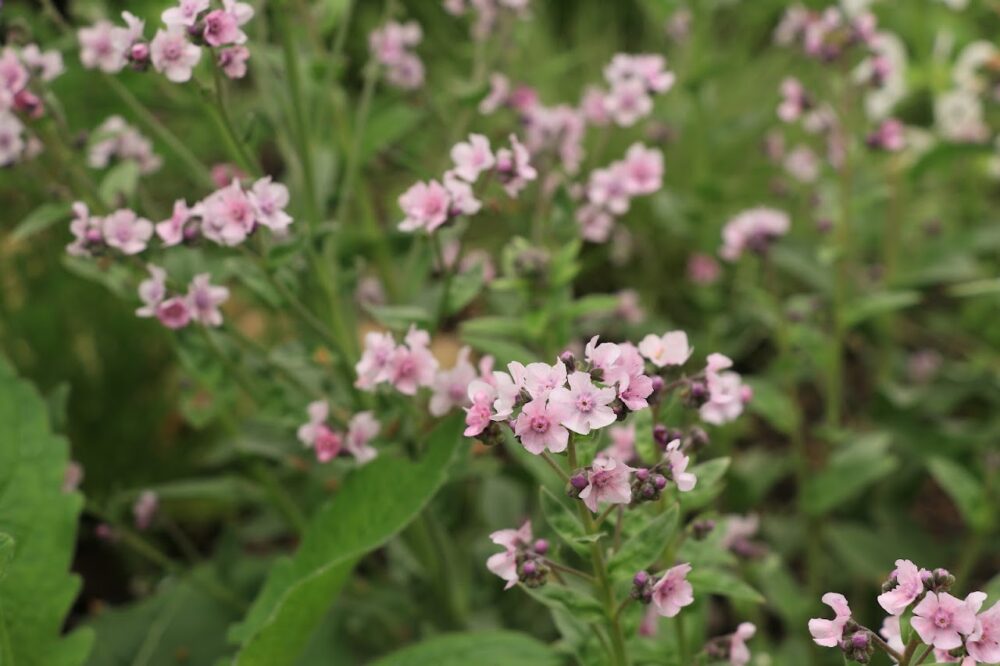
231, 415, 463, 666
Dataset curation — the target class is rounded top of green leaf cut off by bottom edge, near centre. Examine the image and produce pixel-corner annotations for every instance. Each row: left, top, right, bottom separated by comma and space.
373, 631, 563, 666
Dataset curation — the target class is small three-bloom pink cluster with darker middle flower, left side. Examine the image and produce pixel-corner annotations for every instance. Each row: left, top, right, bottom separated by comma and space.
135, 264, 229, 330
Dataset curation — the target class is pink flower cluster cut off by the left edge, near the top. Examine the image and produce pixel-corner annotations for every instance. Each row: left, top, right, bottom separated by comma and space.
0, 44, 63, 166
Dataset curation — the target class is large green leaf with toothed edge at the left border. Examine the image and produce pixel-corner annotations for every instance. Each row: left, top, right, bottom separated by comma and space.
0, 360, 93, 666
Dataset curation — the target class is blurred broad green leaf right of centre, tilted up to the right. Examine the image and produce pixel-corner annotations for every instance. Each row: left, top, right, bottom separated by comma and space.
802, 433, 899, 516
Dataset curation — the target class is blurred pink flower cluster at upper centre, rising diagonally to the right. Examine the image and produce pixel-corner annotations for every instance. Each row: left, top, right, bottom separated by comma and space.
399, 134, 538, 232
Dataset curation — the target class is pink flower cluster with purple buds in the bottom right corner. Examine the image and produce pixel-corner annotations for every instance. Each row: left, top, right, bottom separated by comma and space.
809, 560, 1000, 666
